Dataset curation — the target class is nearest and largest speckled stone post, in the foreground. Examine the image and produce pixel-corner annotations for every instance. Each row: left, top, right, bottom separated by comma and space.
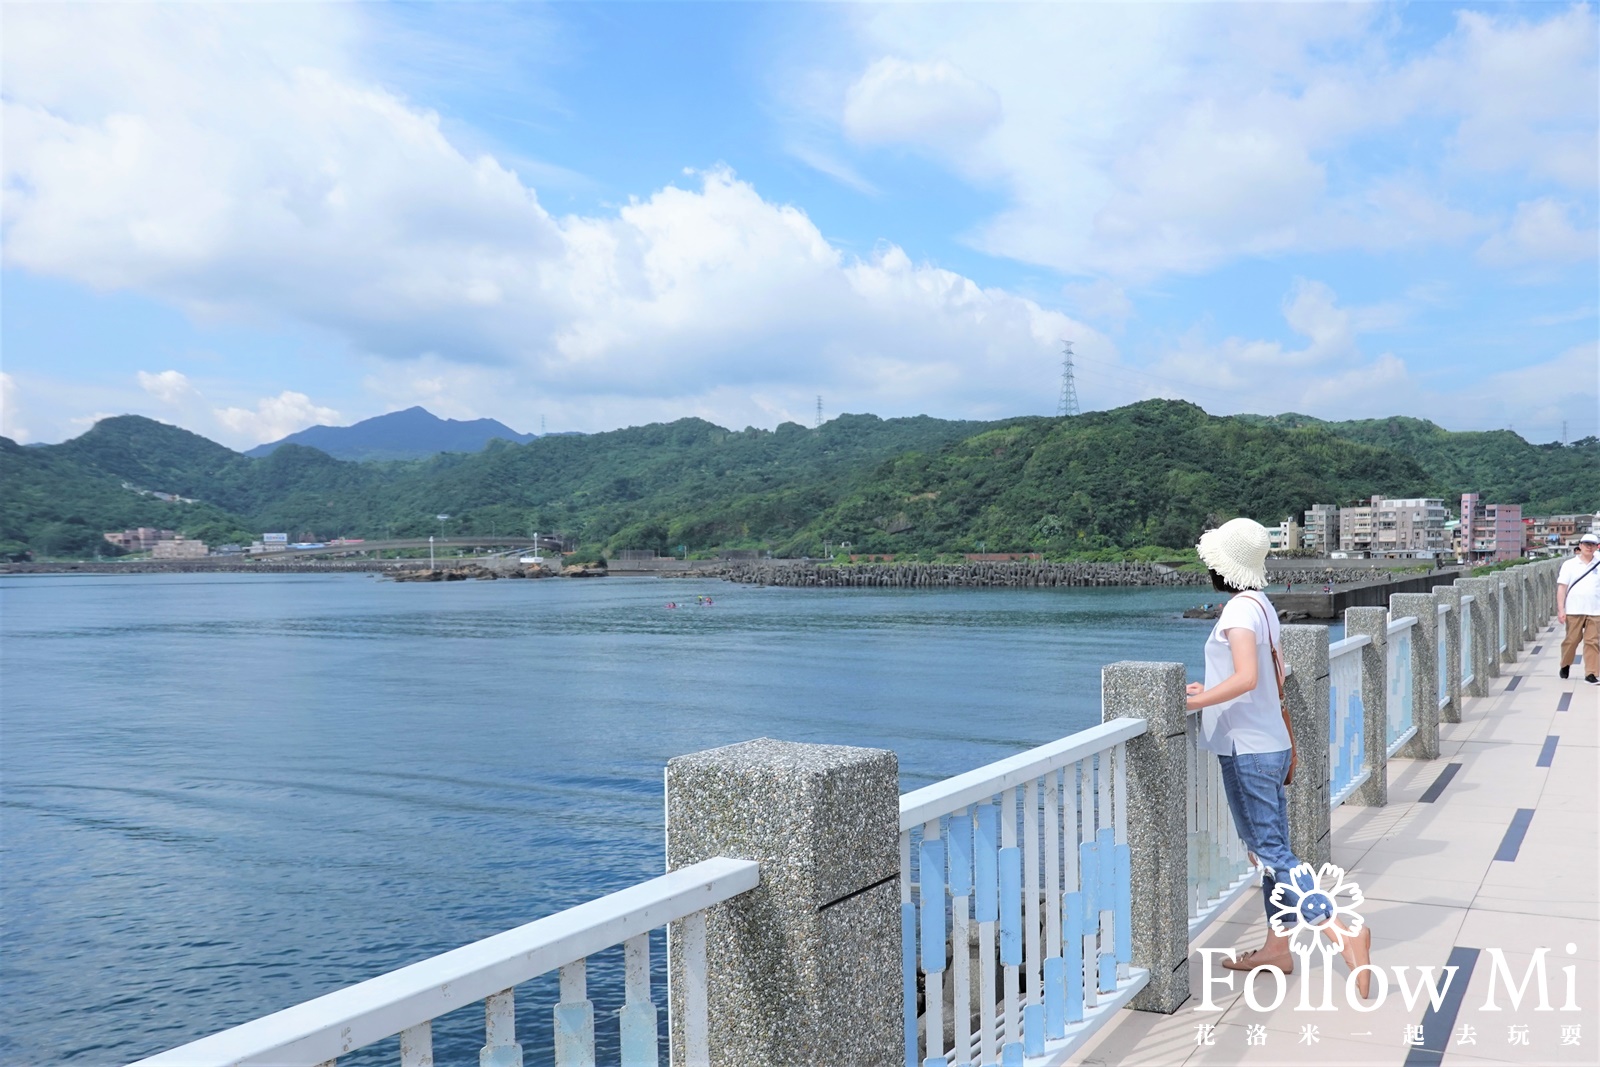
667, 737, 906, 1067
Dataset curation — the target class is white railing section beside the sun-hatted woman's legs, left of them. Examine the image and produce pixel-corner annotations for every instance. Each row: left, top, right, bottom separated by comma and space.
1184, 712, 1261, 941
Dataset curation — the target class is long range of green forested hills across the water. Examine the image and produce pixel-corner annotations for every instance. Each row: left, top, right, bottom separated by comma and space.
0, 400, 1600, 555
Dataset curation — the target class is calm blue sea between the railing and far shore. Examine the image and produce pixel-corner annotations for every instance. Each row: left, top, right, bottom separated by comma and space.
0, 574, 1235, 1067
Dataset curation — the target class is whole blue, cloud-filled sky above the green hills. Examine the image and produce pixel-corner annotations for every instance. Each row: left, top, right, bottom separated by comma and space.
0, 2, 1600, 450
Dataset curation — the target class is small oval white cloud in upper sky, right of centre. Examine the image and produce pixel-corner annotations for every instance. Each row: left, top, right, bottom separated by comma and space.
843, 56, 1000, 149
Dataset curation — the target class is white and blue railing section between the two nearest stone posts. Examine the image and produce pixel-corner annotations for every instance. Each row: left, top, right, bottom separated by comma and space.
901, 718, 1149, 1067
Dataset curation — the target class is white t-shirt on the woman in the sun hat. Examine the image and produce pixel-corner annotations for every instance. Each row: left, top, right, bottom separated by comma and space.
1200, 591, 1292, 755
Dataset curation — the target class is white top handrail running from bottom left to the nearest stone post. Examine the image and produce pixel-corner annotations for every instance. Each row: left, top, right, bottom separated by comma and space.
121, 857, 760, 1067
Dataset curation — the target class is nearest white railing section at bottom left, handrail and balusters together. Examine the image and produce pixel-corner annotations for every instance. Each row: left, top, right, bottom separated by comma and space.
124, 859, 760, 1067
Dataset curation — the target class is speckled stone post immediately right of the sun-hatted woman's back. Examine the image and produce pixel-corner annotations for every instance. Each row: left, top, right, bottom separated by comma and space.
1283, 625, 1333, 867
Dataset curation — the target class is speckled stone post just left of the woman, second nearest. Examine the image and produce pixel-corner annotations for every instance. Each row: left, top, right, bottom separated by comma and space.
1101, 662, 1189, 1014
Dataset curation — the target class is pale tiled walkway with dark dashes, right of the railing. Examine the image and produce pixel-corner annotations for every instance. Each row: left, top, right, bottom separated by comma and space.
1074, 627, 1600, 1067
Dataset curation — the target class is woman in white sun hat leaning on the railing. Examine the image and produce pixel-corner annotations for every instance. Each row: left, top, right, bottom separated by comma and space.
1187, 518, 1373, 998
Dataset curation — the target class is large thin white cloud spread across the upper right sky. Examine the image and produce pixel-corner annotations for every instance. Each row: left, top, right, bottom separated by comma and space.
806, 5, 1600, 282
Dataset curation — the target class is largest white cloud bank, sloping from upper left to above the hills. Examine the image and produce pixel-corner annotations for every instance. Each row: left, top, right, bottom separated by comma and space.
3, 5, 1114, 440
